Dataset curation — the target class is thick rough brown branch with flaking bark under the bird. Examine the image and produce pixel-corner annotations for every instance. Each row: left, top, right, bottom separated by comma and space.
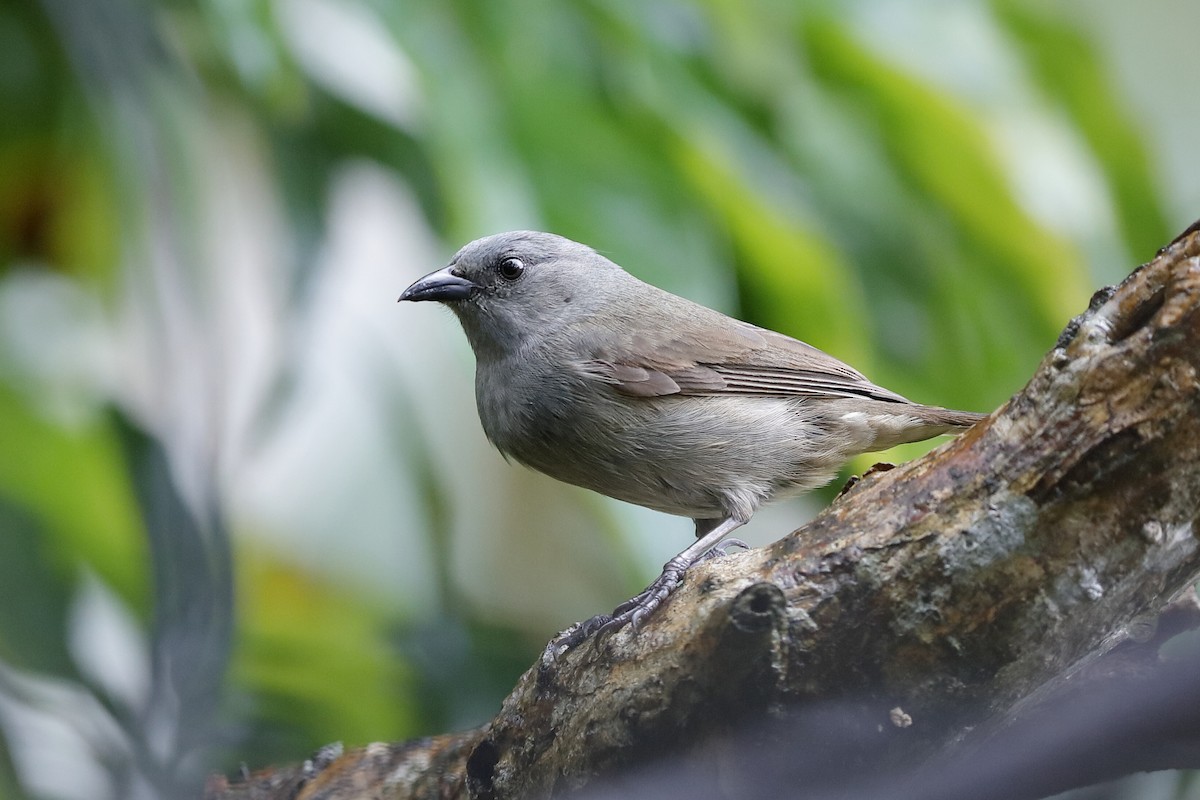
206, 230, 1200, 800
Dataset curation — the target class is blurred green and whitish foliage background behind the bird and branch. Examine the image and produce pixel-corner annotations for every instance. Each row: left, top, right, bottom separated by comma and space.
0, 0, 1200, 798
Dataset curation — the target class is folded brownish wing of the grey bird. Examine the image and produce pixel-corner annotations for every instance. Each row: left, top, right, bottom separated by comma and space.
578, 318, 908, 403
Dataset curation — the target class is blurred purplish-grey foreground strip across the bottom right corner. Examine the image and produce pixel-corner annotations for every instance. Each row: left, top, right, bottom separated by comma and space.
580, 654, 1200, 800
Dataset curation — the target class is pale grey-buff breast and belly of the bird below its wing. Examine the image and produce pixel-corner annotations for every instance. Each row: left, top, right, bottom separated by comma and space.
480, 371, 871, 519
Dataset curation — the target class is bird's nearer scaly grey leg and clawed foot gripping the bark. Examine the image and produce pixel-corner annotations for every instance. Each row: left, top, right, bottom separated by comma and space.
542, 517, 748, 663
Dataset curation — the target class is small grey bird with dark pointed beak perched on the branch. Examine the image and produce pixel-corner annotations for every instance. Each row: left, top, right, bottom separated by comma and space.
400, 230, 984, 640
